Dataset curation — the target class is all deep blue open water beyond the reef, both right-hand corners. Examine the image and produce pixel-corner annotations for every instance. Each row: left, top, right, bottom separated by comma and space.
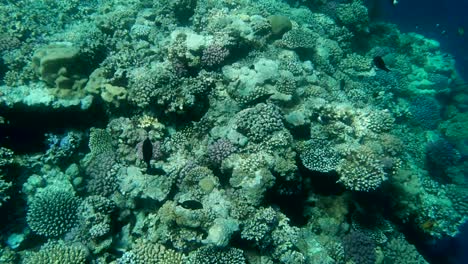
368, 0, 468, 264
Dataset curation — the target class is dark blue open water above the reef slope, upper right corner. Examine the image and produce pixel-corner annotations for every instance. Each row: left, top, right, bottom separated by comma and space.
373, 0, 468, 80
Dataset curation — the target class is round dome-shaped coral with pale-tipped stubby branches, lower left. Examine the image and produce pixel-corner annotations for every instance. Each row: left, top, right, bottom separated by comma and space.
26, 191, 80, 237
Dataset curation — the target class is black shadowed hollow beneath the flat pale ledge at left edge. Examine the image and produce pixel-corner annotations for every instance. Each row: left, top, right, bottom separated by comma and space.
0, 101, 107, 154
